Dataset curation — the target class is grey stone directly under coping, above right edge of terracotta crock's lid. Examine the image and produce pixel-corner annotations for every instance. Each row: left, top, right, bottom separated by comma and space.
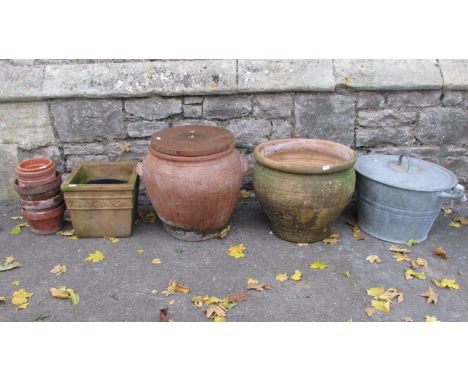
203, 96, 252, 119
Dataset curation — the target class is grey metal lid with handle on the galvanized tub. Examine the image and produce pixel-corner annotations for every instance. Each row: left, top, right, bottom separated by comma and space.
355, 154, 457, 192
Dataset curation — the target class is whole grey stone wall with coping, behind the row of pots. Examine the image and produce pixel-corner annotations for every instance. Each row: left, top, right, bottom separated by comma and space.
0, 60, 468, 203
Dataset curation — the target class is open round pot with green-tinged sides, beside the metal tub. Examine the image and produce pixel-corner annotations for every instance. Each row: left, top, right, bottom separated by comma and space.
253, 138, 356, 243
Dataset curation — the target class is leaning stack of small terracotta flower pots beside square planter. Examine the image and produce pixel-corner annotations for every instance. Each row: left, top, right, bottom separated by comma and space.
15, 158, 65, 235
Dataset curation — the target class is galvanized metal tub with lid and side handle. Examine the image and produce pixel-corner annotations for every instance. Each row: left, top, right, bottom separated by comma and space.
355, 155, 465, 243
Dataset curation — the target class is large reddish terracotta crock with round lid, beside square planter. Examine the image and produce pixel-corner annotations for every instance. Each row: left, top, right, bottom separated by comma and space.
137, 125, 248, 241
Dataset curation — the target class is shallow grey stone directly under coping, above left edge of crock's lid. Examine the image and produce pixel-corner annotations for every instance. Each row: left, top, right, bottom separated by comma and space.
125, 97, 182, 120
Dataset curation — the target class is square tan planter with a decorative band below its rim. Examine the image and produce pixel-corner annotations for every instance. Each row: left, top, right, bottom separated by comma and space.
61, 162, 138, 237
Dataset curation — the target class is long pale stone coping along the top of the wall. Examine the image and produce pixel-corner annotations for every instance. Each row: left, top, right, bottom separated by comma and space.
0, 59, 468, 102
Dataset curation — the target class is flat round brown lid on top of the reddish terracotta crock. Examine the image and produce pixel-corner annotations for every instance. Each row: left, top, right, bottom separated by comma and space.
150, 125, 234, 157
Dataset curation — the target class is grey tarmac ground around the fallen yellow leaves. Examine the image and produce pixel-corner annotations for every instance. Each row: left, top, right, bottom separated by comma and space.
0, 198, 468, 321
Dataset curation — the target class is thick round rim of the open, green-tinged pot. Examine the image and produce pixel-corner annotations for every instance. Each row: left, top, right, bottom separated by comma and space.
254, 138, 357, 174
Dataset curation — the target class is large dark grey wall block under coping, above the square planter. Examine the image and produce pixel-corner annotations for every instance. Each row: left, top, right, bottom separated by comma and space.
51, 100, 126, 142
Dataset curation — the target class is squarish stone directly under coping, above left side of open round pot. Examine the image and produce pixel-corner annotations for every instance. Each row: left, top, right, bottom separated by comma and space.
253, 94, 292, 118
